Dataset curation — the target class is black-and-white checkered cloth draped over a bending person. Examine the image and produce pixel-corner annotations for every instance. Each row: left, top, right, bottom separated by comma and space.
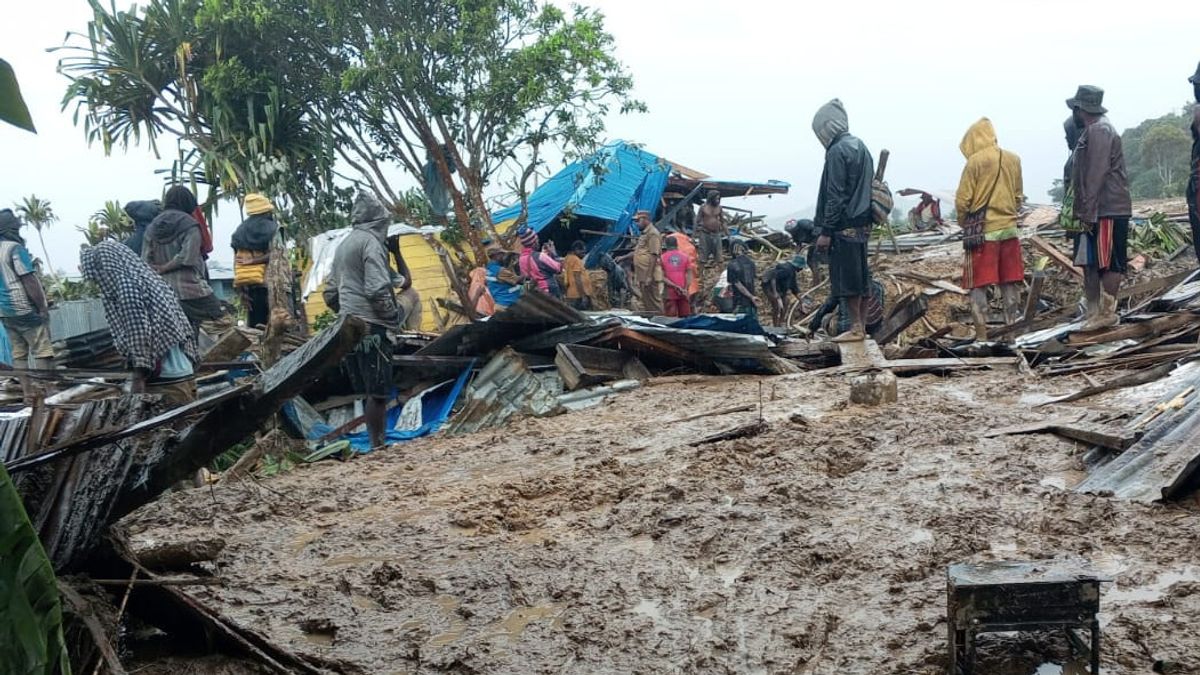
79, 239, 197, 371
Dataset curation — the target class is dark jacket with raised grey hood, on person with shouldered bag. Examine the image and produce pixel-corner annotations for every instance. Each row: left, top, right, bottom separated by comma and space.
812, 98, 875, 241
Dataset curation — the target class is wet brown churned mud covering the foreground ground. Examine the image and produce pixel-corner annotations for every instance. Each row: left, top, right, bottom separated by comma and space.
122, 372, 1200, 675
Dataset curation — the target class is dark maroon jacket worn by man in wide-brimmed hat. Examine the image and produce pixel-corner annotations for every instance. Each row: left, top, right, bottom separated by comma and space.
1070, 117, 1133, 225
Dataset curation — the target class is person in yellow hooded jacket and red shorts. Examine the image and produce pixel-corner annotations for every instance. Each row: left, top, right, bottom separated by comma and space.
954, 118, 1025, 342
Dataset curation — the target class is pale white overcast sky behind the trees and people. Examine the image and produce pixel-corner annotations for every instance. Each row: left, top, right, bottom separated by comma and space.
0, 0, 1200, 274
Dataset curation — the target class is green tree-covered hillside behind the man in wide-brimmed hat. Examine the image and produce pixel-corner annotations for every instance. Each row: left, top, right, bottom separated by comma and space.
1121, 106, 1193, 199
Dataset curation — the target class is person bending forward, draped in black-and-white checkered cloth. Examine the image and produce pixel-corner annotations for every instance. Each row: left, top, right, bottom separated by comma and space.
79, 240, 197, 404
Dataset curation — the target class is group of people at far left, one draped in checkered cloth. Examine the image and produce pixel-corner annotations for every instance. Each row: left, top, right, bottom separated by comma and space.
0, 185, 278, 404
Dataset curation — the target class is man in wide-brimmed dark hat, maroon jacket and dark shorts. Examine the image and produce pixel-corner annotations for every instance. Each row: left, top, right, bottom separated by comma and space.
1067, 84, 1133, 330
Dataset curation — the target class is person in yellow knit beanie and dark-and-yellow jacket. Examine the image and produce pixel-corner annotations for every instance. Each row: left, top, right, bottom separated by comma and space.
230, 192, 280, 328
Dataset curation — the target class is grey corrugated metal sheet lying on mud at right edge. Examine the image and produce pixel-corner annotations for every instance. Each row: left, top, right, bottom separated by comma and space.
1075, 364, 1200, 503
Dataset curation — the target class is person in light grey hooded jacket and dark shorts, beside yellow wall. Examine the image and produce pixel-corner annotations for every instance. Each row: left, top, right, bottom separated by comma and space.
323, 192, 401, 449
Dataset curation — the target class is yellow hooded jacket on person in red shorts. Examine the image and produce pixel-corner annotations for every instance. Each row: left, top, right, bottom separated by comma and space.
954, 118, 1025, 241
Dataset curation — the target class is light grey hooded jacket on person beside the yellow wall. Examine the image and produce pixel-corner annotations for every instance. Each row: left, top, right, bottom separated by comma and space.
323, 192, 400, 327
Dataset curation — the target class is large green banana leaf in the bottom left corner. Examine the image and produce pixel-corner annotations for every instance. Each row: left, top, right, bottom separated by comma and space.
0, 466, 71, 675
